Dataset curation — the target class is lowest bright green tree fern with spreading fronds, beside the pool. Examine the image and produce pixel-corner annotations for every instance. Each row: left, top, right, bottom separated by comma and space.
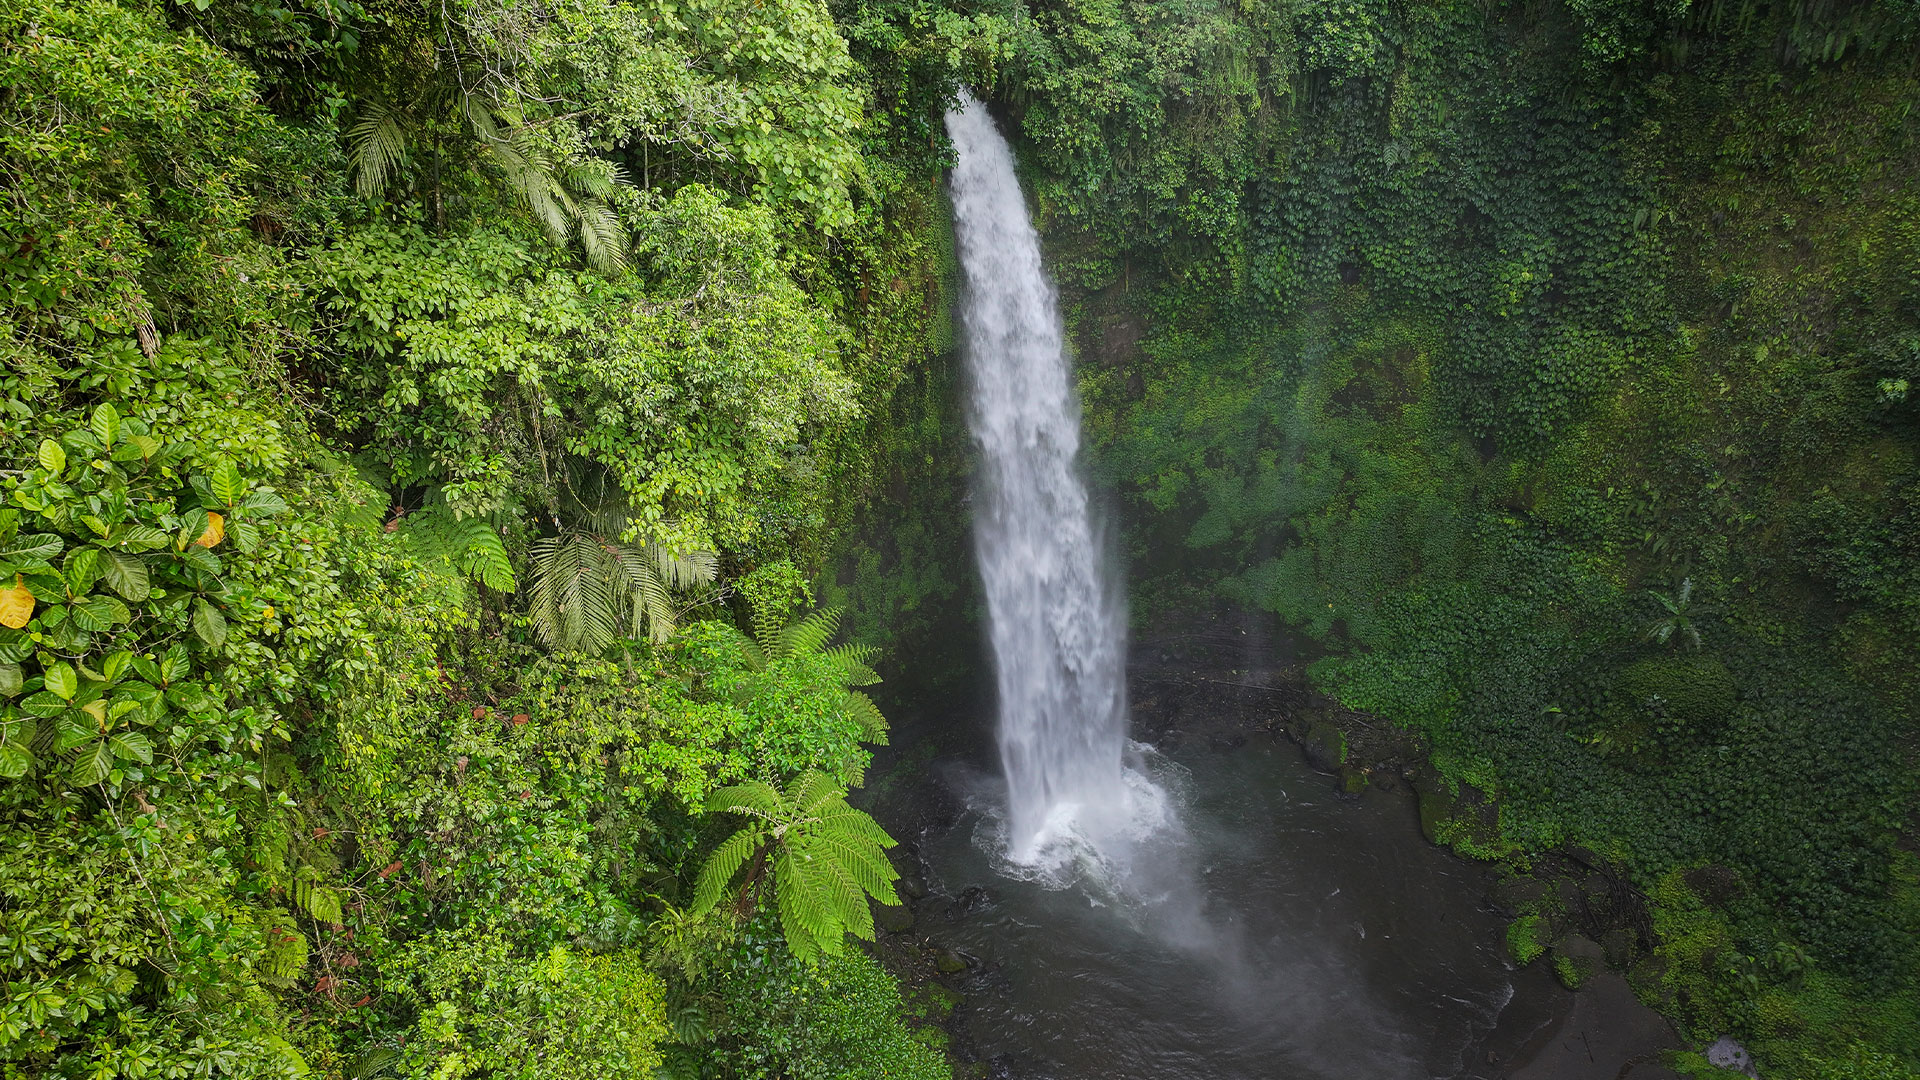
693, 769, 900, 961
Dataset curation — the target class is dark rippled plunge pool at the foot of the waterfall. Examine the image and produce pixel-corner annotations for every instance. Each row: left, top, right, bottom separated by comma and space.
918, 736, 1513, 1080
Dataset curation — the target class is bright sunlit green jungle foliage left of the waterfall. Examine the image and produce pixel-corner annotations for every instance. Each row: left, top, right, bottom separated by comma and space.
0, 0, 977, 1078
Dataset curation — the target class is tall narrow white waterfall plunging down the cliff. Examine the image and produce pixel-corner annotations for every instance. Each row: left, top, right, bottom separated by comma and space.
947, 94, 1140, 865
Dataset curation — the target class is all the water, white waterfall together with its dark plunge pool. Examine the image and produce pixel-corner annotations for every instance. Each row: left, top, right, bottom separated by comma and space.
927, 98, 1513, 1080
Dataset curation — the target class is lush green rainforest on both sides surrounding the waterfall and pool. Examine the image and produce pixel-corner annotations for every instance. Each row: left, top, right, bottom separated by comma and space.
0, 0, 1920, 1080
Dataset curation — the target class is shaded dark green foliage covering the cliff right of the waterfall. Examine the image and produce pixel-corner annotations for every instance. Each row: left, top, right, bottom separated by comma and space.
1006, 2, 1920, 1076
